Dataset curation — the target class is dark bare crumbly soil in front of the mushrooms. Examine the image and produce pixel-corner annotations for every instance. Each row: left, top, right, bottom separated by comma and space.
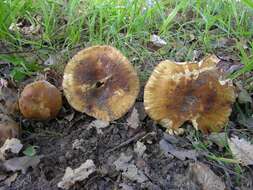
0, 91, 252, 190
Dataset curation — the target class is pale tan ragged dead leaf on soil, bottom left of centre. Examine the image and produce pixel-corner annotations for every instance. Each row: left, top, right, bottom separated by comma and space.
57, 160, 96, 189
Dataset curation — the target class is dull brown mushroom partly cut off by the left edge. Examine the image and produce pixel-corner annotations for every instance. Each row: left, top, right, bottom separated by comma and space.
0, 114, 21, 146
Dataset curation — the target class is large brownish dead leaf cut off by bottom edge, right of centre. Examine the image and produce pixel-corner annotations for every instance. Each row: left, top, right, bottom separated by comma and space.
189, 163, 226, 190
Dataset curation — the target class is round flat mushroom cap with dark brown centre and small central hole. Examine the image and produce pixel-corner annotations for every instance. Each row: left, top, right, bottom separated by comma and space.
63, 46, 139, 121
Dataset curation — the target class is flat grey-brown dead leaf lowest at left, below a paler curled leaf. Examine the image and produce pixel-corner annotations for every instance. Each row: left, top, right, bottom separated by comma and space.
3, 156, 42, 174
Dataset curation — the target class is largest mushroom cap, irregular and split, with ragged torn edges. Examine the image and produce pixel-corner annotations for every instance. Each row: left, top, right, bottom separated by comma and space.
144, 55, 235, 133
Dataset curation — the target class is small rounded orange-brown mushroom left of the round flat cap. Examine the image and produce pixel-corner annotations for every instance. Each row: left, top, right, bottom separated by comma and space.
19, 80, 62, 120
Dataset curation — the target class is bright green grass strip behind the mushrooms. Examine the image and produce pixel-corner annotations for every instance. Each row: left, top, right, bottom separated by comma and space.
0, 0, 253, 62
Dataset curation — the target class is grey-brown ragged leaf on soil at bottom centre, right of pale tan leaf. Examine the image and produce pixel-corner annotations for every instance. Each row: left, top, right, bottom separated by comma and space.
113, 153, 148, 183
